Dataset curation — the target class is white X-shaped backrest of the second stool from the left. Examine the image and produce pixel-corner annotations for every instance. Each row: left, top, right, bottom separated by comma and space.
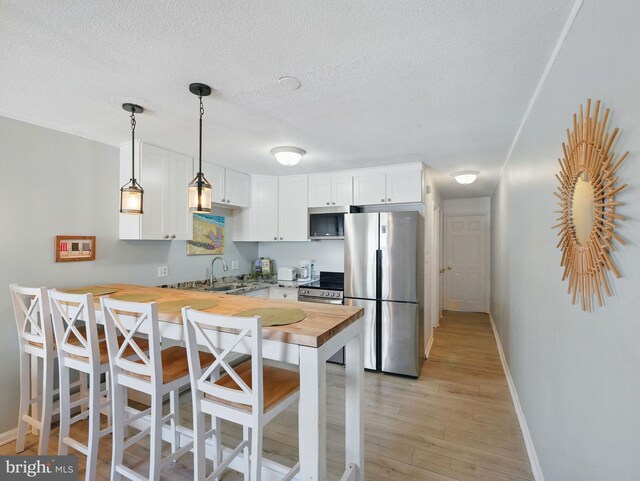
49, 290, 100, 364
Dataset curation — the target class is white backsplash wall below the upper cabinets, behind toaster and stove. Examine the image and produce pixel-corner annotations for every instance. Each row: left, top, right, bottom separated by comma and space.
260, 240, 344, 273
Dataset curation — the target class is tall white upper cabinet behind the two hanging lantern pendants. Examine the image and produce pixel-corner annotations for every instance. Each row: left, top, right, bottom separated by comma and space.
120, 141, 194, 240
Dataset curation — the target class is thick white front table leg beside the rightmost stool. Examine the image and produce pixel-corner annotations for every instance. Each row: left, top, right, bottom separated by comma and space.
298, 346, 327, 481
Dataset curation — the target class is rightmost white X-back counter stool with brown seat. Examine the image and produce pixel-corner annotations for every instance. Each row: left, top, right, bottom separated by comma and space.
182, 308, 300, 481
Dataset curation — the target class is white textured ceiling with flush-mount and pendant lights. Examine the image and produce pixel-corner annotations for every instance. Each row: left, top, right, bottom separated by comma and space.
0, 0, 573, 198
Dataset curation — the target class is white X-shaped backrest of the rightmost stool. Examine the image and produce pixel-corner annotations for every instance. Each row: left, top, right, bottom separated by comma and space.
182, 307, 264, 413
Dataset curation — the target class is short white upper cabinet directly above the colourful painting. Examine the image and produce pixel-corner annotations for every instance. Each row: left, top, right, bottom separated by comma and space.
202, 162, 251, 207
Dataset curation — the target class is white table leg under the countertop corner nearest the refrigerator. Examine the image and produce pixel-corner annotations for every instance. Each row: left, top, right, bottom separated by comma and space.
344, 322, 364, 481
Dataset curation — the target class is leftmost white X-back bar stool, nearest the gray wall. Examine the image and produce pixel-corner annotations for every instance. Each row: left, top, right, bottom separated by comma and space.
9, 284, 56, 456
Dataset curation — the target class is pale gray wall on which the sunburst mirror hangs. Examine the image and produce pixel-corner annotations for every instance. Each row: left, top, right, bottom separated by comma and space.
491, 0, 640, 481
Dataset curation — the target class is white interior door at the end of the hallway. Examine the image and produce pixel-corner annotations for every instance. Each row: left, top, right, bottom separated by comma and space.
444, 215, 487, 312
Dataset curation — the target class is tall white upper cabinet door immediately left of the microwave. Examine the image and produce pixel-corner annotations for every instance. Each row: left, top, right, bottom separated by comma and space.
278, 175, 309, 241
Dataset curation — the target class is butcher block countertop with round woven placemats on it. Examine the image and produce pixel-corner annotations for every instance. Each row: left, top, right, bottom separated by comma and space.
77, 284, 364, 347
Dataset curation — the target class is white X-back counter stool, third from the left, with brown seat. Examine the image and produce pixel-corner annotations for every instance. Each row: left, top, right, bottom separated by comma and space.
101, 297, 214, 481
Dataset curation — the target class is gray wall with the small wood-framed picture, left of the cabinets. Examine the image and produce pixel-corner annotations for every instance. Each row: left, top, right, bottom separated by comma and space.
0, 117, 258, 433
